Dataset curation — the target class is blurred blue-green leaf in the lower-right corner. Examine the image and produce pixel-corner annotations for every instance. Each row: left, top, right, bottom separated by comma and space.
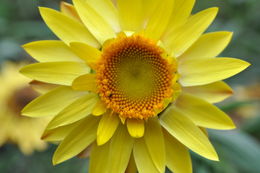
209, 130, 260, 173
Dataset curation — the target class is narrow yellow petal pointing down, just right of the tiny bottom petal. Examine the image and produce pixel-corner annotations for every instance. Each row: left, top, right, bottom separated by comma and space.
144, 117, 166, 173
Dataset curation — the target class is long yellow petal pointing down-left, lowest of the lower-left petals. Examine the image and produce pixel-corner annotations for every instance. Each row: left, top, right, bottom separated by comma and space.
52, 116, 99, 165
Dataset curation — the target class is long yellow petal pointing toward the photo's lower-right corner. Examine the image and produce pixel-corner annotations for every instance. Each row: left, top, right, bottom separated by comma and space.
160, 108, 218, 160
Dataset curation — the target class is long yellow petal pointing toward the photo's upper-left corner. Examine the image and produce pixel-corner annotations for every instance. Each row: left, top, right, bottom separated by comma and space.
39, 7, 100, 47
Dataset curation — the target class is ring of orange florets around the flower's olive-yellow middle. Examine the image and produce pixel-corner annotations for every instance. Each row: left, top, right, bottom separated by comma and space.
97, 35, 176, 119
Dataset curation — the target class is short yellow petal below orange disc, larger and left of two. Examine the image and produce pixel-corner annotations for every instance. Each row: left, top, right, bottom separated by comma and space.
97, 112, 119, 145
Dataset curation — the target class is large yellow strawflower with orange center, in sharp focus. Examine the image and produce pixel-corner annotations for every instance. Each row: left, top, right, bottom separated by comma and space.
21, 0, 249, 173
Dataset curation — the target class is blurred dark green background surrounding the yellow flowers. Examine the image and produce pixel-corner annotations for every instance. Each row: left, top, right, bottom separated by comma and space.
0, 0, 260, 173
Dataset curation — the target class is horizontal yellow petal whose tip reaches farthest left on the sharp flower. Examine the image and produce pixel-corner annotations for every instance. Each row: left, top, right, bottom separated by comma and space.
20, 62, 90, 85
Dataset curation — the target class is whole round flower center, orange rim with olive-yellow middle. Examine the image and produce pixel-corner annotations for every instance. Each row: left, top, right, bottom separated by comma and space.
97, 35, 176, 119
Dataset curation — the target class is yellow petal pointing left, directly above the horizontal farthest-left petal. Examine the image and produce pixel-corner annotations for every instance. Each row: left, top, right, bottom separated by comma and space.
23, 40, 83, 62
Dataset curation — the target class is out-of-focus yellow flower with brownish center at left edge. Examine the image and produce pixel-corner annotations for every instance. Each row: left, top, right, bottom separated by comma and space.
0, 63, 47, 155
